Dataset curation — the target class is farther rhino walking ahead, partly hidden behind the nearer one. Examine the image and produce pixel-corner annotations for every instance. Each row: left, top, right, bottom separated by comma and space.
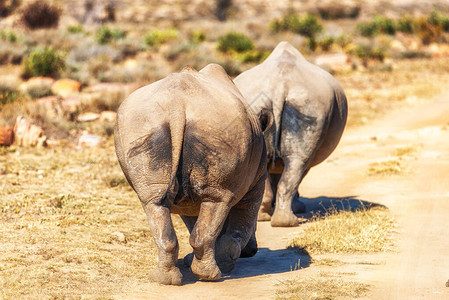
234, 42, 347, 227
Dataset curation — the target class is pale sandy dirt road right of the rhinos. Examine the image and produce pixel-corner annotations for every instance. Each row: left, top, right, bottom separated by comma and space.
122, 93, 449, 299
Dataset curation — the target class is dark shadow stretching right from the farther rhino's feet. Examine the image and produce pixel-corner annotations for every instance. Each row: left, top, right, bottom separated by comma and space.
296, 196, 387, 223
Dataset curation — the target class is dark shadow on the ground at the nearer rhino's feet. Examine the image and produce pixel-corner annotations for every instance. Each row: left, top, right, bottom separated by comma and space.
178, 248, 311, 285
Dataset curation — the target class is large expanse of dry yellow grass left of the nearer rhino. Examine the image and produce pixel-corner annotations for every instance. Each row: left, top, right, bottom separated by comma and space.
0, 140, 188, 299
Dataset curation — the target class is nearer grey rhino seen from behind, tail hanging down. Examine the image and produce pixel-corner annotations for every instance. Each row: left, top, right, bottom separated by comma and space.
114, 64, 267, 285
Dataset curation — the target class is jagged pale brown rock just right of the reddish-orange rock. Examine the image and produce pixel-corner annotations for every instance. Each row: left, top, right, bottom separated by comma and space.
14, 116, 47, 147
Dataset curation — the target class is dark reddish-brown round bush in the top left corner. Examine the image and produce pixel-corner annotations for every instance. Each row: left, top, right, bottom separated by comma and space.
22, 0, 61, 29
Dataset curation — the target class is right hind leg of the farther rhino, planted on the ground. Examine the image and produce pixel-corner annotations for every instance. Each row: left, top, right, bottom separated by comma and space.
271, 157, 306, 227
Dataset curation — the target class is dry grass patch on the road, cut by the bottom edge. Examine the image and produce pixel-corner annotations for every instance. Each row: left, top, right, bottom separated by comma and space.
276, 273, 369, 300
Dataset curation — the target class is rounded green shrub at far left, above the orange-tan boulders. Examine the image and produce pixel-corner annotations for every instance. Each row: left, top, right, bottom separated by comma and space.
23, 48, 65, 78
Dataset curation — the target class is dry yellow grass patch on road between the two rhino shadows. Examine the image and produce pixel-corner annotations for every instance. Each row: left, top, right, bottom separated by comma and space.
290, 208, 395, 254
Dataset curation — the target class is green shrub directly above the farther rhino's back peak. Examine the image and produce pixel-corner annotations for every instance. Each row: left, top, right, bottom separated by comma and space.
269, 14, 323, 37
